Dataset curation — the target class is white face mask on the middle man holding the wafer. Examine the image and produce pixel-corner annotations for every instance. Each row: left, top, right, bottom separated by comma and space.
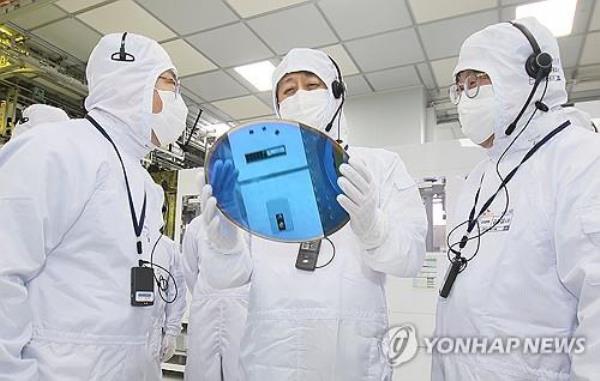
279, 89, 333, 131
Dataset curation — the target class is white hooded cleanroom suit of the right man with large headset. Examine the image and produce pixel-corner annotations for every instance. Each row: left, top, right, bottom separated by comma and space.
432, 19, 600, 381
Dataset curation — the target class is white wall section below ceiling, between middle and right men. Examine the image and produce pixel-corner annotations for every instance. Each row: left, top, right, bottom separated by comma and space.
344, 88, 426, 147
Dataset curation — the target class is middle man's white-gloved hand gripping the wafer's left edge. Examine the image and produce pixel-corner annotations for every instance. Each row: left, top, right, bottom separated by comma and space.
201, 185, 242, 254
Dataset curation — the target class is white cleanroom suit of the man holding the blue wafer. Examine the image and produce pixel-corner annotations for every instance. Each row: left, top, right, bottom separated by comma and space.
201, 49, 427, 381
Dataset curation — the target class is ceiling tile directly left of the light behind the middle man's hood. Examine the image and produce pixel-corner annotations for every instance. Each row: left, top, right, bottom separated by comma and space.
181, 71, 250, 102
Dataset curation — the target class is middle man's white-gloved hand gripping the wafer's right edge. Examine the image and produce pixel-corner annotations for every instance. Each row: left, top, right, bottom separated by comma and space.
337, 157, 386, 249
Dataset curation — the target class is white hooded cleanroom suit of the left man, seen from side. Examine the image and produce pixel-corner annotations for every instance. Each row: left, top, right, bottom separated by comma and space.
0, 34, 185, 381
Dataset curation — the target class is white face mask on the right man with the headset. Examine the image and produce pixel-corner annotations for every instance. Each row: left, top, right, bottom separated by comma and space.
458, 85, 497, 144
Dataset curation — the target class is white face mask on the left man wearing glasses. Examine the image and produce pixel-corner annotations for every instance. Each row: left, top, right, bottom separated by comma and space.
150, 89, 188, 147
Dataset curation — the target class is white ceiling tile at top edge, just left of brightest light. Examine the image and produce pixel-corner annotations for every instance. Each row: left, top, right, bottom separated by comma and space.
409, 0, 498, 23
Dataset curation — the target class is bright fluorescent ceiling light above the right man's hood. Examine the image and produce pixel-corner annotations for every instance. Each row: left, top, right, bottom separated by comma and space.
516, 0, 577, 37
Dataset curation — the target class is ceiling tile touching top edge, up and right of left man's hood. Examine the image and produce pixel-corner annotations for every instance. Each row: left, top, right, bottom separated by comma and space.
137, 0, 239, 35
